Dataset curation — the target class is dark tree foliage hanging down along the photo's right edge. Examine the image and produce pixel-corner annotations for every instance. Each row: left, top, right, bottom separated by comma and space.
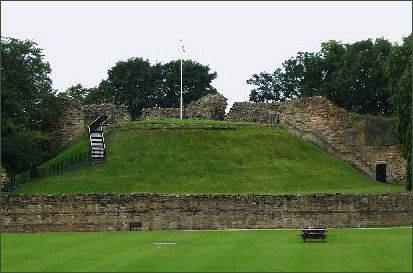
386, 34, 413, 190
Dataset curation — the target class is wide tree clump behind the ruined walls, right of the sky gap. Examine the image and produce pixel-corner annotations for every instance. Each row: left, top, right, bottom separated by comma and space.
247, 39, 393, 115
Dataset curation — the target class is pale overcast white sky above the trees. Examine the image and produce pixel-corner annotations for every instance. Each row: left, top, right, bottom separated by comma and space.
1, 1, 412, 110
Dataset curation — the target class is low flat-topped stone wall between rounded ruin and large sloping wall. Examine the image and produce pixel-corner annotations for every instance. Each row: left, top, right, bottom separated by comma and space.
225, 102, 278, 123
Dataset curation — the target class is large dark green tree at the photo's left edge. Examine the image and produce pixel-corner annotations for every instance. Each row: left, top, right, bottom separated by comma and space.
1, 37, 58, 173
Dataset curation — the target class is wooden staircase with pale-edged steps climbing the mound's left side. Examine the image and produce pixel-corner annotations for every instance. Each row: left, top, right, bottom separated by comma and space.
89, 115, 110, 164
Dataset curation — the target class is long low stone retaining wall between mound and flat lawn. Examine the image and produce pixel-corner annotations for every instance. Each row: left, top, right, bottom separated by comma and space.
1, 193, 412, 232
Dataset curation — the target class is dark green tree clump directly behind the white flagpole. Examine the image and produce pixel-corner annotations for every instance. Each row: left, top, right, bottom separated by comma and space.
100, 58, 217, 118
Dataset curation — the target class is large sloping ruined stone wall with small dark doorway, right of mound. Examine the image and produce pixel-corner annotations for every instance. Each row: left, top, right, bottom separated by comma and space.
278, 97, 406, 182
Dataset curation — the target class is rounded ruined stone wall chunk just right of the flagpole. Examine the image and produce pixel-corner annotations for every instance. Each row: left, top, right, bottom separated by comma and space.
185, 93, 227, 120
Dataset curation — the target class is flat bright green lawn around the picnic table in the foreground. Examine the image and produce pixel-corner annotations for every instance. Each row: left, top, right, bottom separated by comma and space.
1, 228, 412, 272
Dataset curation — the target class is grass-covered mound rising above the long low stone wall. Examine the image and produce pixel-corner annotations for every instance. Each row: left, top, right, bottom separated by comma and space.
15, 120, 404, 194
